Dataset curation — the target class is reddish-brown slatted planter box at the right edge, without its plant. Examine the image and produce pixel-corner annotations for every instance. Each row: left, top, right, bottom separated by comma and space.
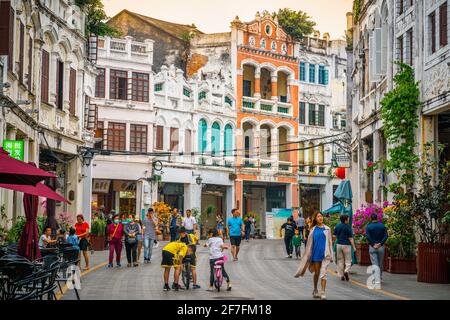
417, 243, 450, 283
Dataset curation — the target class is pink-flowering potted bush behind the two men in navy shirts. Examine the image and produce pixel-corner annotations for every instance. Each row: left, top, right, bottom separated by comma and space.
353, 204, 383, 266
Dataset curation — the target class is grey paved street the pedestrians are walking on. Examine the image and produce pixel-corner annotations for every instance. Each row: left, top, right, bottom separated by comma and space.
62, 240, 450, 300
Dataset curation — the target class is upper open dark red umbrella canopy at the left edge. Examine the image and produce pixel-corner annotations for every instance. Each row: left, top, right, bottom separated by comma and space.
0, 148, 56, 185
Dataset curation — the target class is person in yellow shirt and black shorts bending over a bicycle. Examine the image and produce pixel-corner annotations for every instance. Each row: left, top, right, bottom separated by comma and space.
161, 241, 188, 291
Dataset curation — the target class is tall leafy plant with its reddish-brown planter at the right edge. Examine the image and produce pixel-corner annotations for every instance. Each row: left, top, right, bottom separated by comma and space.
413, 144, 450, 283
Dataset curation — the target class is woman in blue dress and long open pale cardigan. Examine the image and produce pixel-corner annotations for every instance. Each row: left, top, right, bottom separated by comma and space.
295, 212, 333, 300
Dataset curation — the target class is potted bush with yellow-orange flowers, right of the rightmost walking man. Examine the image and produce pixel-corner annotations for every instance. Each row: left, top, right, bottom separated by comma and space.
383, 198, 417, 274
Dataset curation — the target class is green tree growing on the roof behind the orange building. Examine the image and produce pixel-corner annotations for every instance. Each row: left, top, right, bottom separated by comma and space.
272, 8, 316, 41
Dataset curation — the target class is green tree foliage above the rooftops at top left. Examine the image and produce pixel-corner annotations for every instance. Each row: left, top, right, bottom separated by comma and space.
76, 0, 120, 37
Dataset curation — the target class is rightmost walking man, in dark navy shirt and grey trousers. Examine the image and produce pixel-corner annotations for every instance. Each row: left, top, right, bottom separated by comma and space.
366, 213, 388, 284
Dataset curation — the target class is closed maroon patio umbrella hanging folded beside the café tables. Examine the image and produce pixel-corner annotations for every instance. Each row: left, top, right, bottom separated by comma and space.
17, 194, 41, 261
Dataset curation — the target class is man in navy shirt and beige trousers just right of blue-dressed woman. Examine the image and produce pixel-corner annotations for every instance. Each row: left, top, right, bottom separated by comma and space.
334, 214, 356, 281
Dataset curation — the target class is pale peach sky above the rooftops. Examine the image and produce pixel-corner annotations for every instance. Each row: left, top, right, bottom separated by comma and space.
103, 0, 353, 39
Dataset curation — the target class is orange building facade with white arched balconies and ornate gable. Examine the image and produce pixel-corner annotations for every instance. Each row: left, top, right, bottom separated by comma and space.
231, 14, 299, 232
